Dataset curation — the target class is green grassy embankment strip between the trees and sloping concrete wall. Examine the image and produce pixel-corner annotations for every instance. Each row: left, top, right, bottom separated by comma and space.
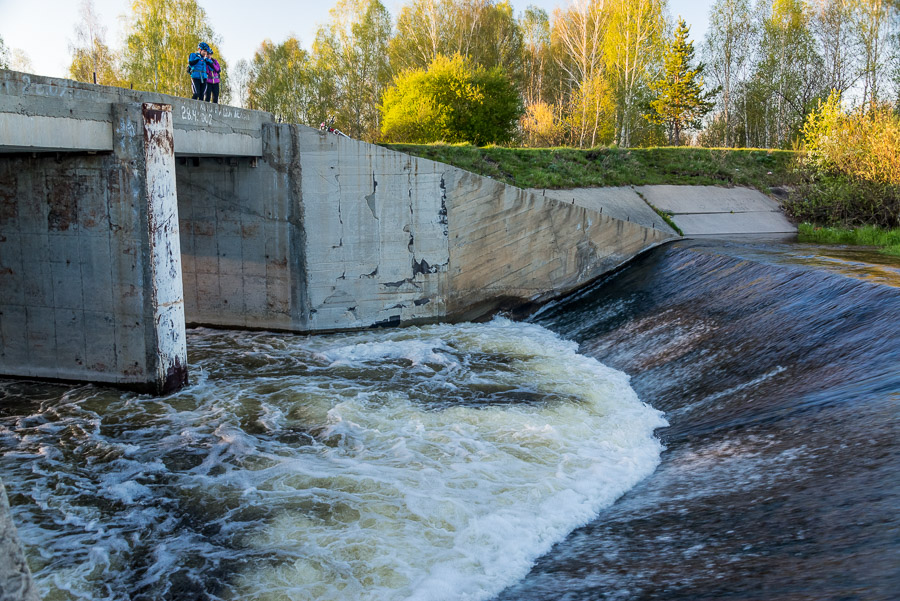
385, 144, 795, 193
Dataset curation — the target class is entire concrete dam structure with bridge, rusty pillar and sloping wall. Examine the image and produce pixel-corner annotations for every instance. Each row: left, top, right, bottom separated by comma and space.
0, 71, 677, 394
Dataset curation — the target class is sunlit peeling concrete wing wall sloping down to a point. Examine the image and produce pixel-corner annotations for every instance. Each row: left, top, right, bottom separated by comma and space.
297, 128, 672, 330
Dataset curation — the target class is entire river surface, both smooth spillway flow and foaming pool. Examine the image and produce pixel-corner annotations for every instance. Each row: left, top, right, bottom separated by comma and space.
0, 241, 900, 601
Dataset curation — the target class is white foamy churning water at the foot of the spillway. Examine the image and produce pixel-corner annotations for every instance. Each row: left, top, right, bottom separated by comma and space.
0, 319, 665, 600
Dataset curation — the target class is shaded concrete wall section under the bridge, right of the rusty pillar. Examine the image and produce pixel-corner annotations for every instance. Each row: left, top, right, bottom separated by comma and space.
176, 125, 306, 330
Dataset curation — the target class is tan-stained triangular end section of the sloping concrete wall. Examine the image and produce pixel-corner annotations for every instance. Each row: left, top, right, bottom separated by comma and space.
445, 169, 675, 316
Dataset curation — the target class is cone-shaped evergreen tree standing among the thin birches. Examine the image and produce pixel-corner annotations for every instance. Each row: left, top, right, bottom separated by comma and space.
644, 17, 715, 146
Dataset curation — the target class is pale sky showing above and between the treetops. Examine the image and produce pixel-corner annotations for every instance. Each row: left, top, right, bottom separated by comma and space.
0, 0, 713, 77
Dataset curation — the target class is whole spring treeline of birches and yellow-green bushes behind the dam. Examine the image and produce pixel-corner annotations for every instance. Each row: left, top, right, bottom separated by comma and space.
0, 0, 900, 148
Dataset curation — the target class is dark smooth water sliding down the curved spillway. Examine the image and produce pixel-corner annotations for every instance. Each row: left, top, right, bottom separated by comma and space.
498, 242, 900, 601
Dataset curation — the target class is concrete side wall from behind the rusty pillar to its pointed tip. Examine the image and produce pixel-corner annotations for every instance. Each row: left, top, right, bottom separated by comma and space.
177, 125, 674, 332
